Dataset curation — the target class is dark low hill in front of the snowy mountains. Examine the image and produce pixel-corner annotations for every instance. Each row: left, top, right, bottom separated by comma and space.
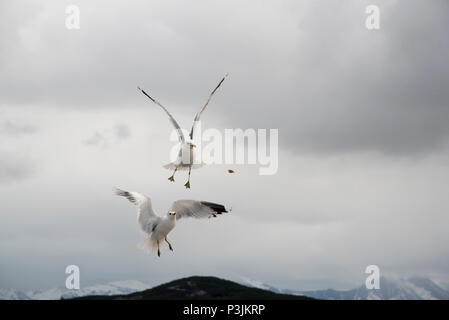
72, 276, 311, 300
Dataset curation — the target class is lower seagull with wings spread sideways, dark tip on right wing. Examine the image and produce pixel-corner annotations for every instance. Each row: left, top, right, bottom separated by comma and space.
115, 188, 228, 257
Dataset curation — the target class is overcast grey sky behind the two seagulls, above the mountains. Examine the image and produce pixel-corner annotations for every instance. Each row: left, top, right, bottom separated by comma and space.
0, 0, 449, 289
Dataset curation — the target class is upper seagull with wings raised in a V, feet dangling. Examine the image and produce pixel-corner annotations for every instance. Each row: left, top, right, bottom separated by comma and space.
137, 74, 228, 189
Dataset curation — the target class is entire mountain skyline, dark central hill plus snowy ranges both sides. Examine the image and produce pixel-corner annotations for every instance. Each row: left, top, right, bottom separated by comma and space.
0, 277, 449, 300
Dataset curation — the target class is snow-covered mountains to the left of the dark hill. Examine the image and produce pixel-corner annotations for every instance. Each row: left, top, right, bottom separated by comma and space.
0, 280, 151, 300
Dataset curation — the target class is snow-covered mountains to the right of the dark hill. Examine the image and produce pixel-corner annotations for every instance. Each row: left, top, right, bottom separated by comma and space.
245, 277, 449, 300
